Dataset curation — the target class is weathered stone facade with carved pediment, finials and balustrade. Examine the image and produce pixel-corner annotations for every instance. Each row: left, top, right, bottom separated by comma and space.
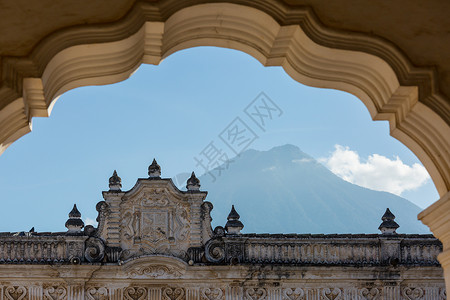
0, 161, 446, 300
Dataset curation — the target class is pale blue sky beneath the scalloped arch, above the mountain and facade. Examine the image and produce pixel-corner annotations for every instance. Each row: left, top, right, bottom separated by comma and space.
0, 47, 438, 231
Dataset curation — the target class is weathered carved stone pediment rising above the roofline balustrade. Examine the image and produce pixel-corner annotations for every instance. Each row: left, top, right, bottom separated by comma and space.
98, 162, 212, 262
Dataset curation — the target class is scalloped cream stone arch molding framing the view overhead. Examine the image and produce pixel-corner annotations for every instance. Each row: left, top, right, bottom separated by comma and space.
0, 1, 450, 196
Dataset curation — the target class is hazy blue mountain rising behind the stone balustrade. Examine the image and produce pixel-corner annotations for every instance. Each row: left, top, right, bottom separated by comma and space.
199, 145, 429, 233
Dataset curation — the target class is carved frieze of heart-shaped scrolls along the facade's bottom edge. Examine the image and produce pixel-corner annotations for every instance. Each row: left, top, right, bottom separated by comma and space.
0, 283, 446, 300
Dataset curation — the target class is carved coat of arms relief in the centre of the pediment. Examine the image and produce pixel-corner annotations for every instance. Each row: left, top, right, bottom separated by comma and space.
121, 188, 190, 258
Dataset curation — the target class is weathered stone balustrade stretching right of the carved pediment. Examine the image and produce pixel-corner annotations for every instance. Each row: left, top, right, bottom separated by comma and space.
205, 234, 442, 265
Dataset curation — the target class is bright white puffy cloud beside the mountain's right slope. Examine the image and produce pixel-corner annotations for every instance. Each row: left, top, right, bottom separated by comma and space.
320, 145, 430, 195
